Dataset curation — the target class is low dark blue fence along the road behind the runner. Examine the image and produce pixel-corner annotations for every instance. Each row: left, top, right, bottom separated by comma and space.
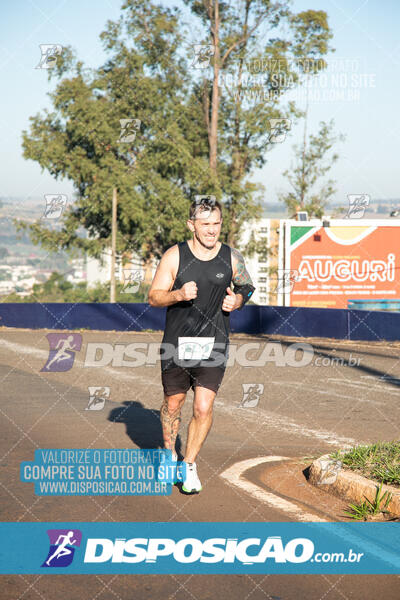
0, 303, 400, 341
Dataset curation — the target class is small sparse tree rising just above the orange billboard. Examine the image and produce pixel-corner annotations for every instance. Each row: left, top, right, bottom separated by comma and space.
279, 120, 344, 218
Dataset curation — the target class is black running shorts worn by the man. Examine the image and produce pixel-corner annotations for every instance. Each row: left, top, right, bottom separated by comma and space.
161, 367, 225, 396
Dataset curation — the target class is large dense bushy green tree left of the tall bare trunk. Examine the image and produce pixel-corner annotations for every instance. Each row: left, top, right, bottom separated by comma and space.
19, 0, 203, 268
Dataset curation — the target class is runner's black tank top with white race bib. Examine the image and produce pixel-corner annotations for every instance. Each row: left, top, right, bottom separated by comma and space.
161, 242, 232, 371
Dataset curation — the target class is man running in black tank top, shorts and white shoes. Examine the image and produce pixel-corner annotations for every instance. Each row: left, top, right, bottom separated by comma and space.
149, 196, 255, 493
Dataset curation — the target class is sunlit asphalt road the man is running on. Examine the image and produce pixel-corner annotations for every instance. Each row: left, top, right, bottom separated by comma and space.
0, 329, 400, 600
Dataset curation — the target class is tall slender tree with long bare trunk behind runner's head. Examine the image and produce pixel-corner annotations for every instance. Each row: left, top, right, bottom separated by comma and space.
185, 0, 332, 245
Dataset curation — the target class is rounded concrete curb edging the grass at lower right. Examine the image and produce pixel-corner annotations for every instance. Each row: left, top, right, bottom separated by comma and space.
309, 454, 400, 517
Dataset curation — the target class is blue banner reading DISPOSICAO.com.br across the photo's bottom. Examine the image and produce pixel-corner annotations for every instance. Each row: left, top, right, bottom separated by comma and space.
0, 522, 400, 575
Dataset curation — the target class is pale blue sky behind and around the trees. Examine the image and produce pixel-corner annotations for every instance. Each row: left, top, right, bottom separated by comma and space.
0, 0, 400, 204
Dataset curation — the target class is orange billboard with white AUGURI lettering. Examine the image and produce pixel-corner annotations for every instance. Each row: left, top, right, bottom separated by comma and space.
281, 219, 400, 308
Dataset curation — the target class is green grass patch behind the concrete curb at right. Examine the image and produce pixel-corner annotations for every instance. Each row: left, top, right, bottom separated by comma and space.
331, 441, 400, 486
